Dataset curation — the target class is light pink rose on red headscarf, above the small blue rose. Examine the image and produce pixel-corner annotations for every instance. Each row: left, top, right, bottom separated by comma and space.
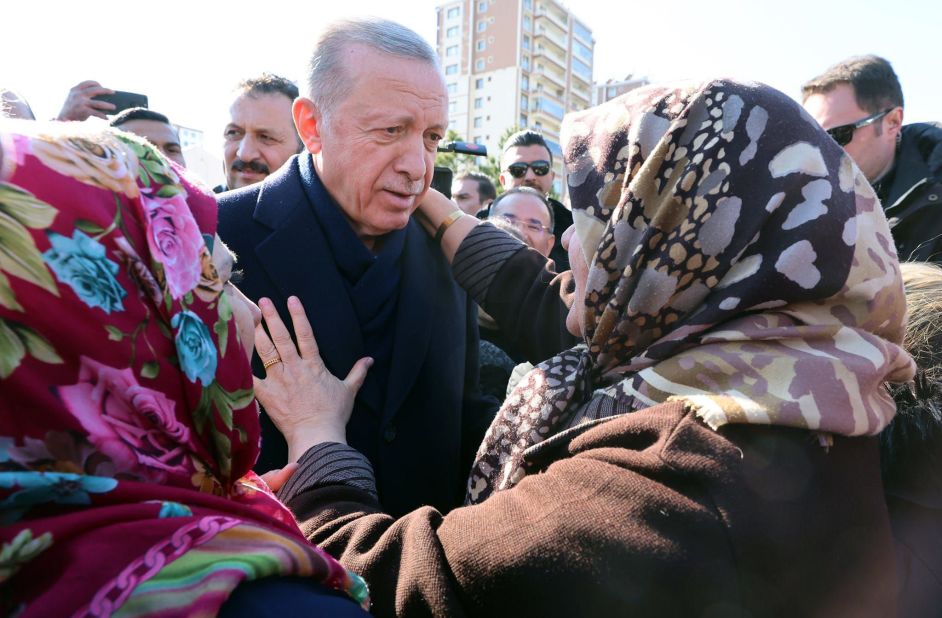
141, 194, 206, 299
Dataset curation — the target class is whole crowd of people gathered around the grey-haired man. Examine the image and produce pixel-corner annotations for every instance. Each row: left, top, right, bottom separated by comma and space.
0, 14, 942, 617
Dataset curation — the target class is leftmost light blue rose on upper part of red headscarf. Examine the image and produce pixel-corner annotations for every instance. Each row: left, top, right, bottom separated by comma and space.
43, 230, 127, 313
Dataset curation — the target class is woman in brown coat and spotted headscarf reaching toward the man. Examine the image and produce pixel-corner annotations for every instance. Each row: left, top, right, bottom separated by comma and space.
263, 81, 913, 616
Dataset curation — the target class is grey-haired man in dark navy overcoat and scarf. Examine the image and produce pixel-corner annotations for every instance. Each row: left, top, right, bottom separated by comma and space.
219, 19, 496, 514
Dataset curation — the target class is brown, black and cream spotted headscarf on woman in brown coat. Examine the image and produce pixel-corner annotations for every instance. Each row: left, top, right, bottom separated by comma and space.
467, 80, 913, 503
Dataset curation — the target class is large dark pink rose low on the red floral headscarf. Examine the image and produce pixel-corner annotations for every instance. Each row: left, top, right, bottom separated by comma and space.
58, 356, 191, 481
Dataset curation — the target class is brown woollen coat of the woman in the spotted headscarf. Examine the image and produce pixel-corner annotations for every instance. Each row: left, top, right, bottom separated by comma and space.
289, 403, 895, 617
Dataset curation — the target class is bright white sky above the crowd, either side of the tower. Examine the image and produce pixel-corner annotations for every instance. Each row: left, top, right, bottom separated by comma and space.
0, 0, 942, 141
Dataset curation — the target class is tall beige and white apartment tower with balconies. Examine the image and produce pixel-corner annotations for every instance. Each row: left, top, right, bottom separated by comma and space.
436, 0, 595, 195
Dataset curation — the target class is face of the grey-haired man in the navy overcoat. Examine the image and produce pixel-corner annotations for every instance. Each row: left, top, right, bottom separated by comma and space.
302, 45, 448, 246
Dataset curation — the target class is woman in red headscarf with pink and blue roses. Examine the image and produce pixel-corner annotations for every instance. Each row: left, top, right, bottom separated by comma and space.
0, 121, 368, 618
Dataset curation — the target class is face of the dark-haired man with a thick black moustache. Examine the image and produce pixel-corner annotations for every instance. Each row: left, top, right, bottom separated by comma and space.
223, 93, 299, 189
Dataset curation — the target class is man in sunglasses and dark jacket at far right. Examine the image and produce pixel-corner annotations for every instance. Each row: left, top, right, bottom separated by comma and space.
802, 56, 942, 263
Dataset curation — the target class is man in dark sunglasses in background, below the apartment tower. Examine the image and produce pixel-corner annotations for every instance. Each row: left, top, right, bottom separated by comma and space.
500, 130, 572, 272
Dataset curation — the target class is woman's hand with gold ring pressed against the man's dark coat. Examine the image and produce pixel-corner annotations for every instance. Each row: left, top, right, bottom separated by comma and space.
255, 296, 373, 462
